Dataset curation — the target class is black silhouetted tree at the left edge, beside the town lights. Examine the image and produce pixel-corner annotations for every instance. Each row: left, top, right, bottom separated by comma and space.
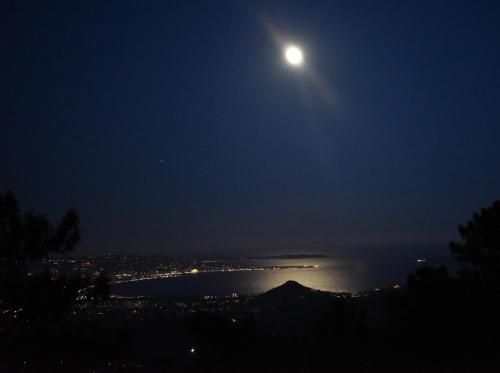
0, 192, 109, 320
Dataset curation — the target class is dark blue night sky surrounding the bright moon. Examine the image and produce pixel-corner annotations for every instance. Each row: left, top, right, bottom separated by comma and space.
0, 0, 500, 254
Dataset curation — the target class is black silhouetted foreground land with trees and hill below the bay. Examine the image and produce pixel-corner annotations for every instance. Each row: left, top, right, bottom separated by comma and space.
0, 193, 500, 372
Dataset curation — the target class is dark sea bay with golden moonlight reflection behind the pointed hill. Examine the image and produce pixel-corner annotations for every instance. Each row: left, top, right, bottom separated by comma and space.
112, 251, 453, 297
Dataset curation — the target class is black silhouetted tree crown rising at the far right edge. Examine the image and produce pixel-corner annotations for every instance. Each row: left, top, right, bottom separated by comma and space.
450, 201, 500, 283
